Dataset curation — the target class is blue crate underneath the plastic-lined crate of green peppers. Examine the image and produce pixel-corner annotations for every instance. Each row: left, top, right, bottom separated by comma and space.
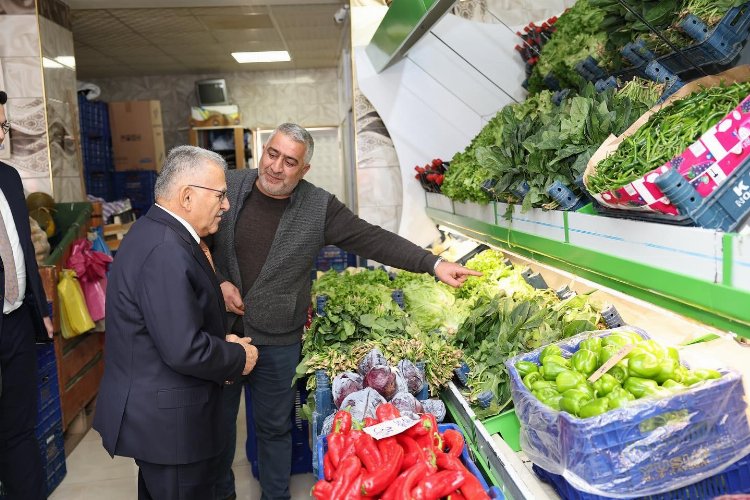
532, 455, 750, 500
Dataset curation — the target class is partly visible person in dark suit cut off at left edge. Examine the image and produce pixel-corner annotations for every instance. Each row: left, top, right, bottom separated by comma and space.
0, 91, 52, 500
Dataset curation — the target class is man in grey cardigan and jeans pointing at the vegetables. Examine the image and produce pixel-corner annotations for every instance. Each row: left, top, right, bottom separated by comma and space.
212, 123, 479, 500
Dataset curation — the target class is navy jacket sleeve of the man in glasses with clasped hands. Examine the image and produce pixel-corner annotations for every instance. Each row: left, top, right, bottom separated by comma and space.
138, 243, 245, 384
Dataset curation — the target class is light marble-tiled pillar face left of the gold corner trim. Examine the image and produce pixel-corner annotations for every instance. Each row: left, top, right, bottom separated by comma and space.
0, 0, 52, 193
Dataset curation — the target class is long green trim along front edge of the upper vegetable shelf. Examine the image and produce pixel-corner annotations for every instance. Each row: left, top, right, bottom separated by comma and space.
426, 208, 750, 338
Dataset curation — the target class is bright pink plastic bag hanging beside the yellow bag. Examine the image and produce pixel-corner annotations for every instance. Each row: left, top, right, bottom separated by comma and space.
65, 239, 112, 321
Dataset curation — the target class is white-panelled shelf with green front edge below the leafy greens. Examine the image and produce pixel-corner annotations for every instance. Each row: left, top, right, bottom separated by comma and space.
426, 194, 750, 337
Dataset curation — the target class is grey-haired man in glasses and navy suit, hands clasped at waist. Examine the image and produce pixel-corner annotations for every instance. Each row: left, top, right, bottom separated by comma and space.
94, 146, 257, 500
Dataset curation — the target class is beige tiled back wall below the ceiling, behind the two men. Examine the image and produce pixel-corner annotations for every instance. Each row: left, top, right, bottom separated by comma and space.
92, 68, 340, 153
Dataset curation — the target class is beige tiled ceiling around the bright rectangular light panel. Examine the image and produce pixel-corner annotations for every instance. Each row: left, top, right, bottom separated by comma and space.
67, 0, 348, 79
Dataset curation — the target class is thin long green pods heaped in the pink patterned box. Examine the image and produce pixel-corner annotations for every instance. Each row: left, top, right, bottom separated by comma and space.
586, 82, 750, 193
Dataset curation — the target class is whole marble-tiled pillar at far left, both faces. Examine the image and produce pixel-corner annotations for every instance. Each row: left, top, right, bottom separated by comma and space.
0, 0, 83, 201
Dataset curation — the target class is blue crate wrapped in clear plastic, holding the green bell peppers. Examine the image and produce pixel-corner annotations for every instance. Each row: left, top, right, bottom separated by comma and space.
506, 327, 750, 495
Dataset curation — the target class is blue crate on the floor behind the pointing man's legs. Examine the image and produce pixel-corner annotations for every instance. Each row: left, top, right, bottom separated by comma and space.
245, 380, 312, 478
